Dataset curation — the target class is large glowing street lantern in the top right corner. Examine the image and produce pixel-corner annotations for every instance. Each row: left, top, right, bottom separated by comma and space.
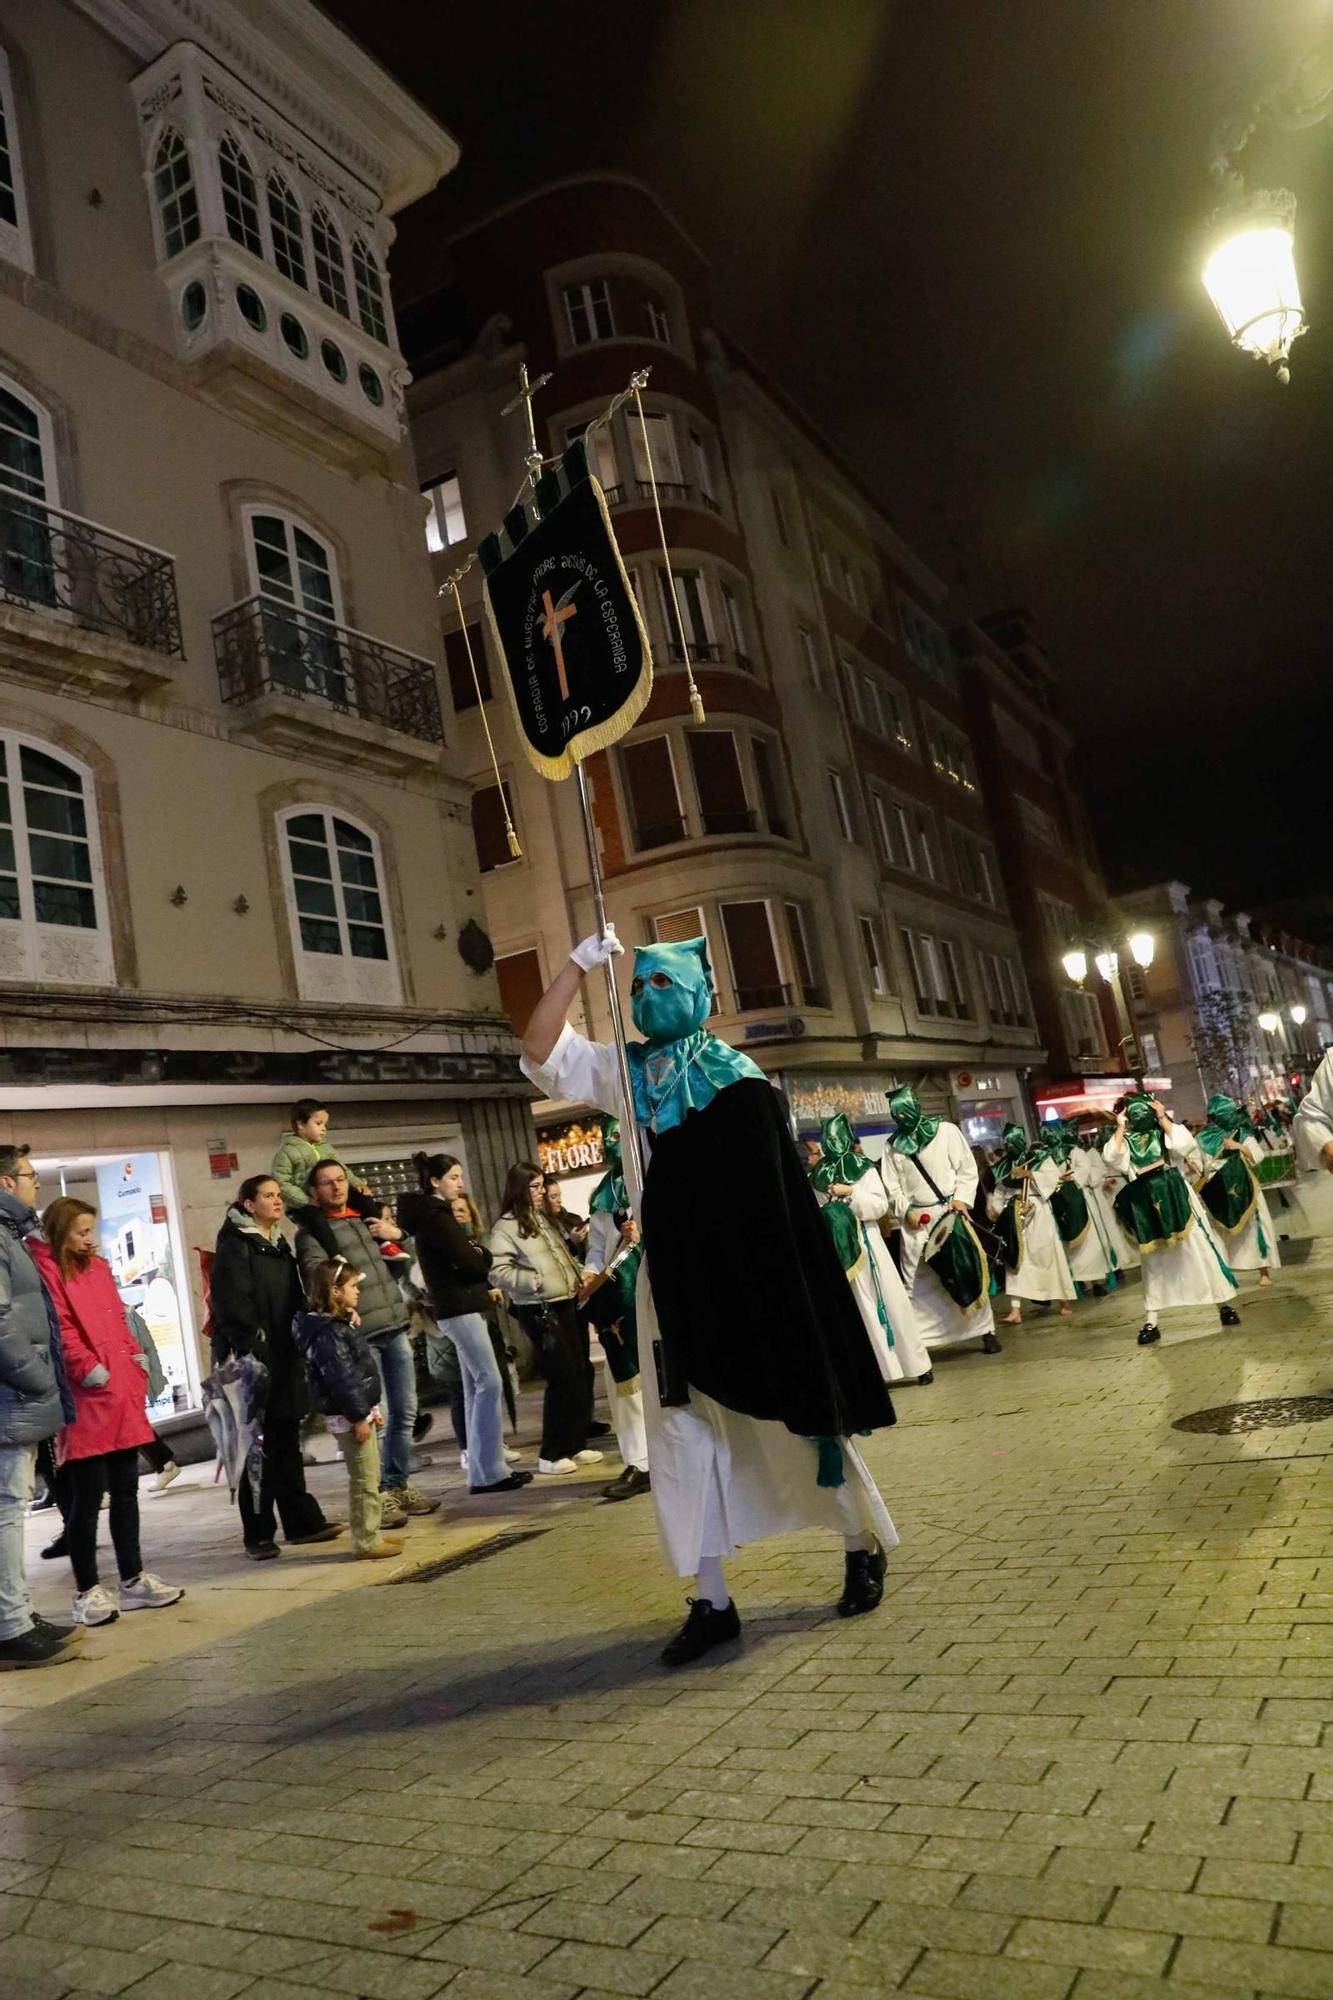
1203, 48, 1333, 382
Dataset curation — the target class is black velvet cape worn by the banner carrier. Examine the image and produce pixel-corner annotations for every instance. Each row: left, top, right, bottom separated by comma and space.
642, 1076, 895, 1438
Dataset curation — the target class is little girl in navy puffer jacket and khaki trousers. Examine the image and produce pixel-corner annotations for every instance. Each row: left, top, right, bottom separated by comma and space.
292, 1256, 402, 1558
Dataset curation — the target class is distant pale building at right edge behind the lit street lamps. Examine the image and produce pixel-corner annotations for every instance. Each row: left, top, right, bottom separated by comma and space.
1117, 882, 1333, 1120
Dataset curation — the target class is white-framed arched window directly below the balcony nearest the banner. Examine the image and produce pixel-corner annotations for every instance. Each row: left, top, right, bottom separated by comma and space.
280, 806, 400, 1006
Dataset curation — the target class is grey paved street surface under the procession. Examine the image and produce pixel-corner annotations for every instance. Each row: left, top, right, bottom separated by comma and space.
0, 1240, 1333, 2000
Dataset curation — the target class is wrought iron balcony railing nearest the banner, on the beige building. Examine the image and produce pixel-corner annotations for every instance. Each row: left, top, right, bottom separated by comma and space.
212, 598, 444, 744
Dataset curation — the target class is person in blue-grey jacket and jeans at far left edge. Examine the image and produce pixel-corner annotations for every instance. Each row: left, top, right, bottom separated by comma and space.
0, 1146, 82, 1668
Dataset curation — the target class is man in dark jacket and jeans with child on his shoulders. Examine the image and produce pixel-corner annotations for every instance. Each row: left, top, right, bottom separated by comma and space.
292, 1160, 440, 1514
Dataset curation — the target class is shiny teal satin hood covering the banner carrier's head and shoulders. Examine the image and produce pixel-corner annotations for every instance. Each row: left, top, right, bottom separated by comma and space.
626, 938, 765, 1132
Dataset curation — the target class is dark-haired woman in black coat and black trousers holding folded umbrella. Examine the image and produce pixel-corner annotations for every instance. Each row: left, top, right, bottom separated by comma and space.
210, 1174, 342, 1562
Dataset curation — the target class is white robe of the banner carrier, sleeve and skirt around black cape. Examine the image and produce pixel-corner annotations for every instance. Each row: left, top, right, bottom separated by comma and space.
522, 1026, 899, 1576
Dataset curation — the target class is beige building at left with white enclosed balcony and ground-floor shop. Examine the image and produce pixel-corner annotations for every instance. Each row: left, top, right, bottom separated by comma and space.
0, 0, 528, 1408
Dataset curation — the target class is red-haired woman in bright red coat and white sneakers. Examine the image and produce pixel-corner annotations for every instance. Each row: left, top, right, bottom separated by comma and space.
30, 1194, 184, 1626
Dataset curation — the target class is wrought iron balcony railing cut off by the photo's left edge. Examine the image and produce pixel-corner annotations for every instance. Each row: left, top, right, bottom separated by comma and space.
0, 492, 184, 660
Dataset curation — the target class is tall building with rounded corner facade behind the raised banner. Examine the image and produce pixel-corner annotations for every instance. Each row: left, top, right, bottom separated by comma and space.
396, 176, 1043, 1168
